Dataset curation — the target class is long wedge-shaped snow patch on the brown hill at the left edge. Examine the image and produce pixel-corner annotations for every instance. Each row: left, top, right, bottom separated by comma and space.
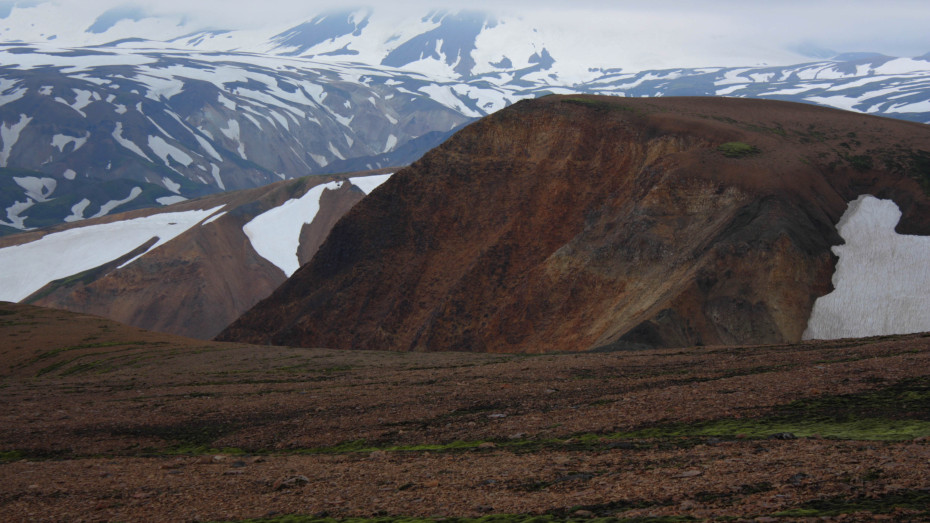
0, 206, 222, 302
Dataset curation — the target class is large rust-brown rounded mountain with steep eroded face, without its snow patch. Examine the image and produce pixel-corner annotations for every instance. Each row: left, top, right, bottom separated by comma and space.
219, 96, 930, 353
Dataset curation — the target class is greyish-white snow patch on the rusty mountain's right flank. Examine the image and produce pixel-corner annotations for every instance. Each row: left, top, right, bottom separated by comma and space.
803, 195, 930, 340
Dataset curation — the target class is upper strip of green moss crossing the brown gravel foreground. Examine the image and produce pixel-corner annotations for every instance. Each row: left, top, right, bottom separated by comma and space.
116, 378, 930, 462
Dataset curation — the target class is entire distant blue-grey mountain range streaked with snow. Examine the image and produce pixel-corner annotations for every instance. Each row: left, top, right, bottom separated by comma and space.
0, 2, 930, 234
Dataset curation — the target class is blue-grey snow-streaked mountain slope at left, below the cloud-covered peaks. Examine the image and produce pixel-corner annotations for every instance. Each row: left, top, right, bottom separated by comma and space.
0, 46, 470, 230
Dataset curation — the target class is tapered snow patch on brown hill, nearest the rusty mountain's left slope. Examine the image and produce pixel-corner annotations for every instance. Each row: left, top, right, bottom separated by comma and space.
242, 182, 342, 277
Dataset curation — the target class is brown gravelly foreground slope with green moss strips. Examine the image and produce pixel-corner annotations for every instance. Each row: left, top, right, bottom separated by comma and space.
0, 304, 930, 521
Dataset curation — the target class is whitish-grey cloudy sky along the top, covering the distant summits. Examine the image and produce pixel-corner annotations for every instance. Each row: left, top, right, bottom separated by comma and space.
141, 0, 930, 56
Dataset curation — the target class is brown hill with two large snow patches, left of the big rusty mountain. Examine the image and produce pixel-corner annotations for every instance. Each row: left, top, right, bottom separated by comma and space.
0, 173, 389, 338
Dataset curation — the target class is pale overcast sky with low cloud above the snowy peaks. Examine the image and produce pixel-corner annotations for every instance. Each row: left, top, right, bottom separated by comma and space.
0, 0, 930, 60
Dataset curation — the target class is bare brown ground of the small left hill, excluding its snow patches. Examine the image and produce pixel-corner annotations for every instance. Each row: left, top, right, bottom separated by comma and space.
0, 171, 390, 339
